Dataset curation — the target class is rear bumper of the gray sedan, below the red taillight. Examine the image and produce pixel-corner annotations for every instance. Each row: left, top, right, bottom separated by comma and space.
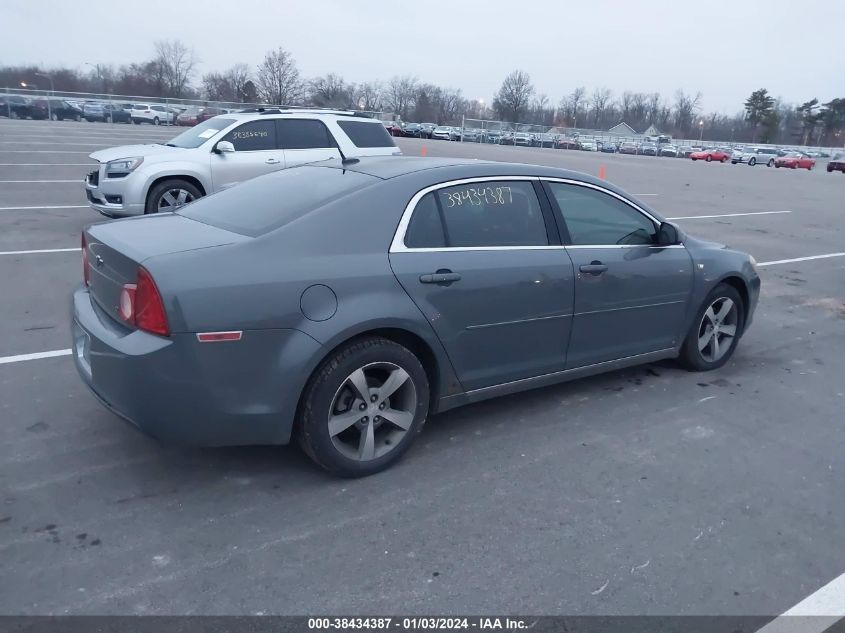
71, 287, 320, 446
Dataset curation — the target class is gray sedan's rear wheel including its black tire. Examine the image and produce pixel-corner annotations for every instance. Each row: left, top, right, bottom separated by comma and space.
296, 337, 429, 477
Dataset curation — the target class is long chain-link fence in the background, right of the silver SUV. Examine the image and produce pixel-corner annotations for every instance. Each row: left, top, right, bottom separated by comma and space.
454, 118, 843, 156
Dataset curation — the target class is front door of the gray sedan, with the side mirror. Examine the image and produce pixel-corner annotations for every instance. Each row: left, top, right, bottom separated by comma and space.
548, 182, 693, 368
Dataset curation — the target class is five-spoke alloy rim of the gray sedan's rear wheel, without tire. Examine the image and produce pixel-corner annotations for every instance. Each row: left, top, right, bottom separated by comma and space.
327, 363, 417, 461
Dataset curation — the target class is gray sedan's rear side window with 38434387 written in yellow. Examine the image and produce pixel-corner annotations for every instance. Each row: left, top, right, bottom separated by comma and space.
405, 181, 549, 248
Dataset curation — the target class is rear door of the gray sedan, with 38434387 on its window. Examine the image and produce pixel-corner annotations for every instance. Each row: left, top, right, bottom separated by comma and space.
390, 178, 573, 390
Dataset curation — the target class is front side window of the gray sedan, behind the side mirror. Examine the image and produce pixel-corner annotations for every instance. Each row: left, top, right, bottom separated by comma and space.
549, 182, 657, 246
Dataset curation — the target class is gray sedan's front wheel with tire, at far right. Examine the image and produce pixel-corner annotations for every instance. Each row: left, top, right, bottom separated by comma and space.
678, 284, 745, 371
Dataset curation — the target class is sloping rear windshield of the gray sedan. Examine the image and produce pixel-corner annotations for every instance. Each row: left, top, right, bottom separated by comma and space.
180, 165, 374, 237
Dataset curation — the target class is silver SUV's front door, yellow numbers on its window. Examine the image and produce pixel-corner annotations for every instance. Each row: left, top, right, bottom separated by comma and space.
211, 119, 285, 191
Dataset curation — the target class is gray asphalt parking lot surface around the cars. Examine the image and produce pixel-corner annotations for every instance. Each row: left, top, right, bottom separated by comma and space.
0, 119, 845, 615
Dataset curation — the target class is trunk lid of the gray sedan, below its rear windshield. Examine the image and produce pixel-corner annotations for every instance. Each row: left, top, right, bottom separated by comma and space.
85, 213, 244, 321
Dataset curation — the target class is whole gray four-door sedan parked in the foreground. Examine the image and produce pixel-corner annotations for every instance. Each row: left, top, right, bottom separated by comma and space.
72, 157, 760, 476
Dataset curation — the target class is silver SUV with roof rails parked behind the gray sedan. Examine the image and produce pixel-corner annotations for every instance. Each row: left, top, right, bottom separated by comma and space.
85, 109, 401, 217
